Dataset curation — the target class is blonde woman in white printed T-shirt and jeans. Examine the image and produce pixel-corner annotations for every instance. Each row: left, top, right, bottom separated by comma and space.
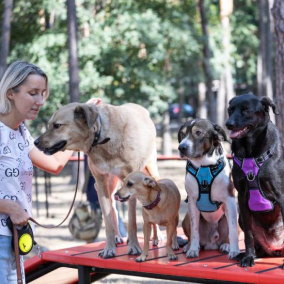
0, 61, 72, 284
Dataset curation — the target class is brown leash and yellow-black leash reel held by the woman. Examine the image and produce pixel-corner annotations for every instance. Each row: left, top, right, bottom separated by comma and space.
11, 152, 80, 284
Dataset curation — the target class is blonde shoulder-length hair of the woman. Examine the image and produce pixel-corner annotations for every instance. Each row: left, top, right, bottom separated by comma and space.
0, 61, 49, 114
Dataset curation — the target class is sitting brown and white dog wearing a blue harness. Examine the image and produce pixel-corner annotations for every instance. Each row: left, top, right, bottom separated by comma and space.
178, 119, 240, 258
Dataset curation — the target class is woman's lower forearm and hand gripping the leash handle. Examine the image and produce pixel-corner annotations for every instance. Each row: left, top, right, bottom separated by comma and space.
0, 199, 29, 226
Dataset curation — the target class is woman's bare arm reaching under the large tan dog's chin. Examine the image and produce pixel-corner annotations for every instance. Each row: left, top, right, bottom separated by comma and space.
29, 147, 73, 174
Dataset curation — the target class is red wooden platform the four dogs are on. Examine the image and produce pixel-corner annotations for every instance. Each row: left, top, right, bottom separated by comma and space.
25, 231, 284, 284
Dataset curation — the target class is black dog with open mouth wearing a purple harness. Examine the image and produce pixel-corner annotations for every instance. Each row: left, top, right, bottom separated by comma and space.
226, 94, 284, 267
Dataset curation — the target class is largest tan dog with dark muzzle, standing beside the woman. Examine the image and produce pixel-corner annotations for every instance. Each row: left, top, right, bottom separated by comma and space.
35, 103, 158, 258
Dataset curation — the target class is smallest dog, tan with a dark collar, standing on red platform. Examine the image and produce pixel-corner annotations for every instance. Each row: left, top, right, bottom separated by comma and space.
115, 172, 180, 262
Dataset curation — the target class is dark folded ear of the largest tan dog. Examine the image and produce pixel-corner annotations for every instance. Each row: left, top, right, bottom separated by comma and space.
74, 105, 98, 128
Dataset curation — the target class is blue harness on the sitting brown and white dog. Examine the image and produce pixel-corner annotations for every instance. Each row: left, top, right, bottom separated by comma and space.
186, 157, 226, 212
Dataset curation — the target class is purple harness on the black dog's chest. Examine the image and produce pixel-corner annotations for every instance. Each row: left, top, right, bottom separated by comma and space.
233, 150, 274, 212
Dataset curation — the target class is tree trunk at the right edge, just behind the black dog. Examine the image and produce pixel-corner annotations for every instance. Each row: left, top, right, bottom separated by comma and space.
272, 0, 284, 144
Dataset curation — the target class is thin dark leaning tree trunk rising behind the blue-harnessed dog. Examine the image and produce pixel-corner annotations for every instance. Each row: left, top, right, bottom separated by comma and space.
198, 0, 216, 122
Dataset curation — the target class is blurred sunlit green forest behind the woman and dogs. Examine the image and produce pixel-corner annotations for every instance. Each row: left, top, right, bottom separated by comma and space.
0, 0, 284, 153
